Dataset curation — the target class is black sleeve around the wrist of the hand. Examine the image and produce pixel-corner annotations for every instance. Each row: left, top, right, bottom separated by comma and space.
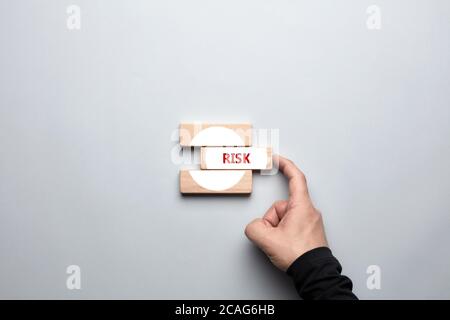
286, 247, 358, 300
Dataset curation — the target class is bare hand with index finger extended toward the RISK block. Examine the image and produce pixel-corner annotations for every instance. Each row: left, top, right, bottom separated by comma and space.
245, 156, 328, 271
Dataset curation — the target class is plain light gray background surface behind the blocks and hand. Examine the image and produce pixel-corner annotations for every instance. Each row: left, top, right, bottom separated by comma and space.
0, 0, 450, 299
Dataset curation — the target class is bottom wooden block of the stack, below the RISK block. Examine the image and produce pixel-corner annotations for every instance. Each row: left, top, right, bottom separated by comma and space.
180, 170, 252, 194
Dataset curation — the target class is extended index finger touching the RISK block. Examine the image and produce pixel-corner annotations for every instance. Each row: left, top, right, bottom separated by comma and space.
278, 156, 309, 202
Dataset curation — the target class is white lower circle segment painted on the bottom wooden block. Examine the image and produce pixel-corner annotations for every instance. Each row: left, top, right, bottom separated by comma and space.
189, 170, 245, 191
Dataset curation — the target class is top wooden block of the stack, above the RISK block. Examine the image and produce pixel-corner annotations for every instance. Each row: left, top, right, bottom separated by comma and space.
180, 123, 252, 147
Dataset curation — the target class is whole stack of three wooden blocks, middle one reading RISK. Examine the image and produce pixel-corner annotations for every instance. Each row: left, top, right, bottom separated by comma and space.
180, 123, 272, 194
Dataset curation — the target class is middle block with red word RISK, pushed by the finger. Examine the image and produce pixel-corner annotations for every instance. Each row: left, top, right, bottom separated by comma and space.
200, 147, 272, 170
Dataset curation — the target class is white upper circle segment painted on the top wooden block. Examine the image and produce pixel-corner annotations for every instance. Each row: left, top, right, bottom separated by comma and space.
190, 127, 245, 146
